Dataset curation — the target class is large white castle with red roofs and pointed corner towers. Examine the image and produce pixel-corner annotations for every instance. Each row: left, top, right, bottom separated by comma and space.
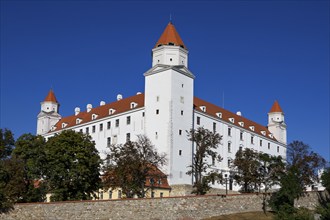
37, 22, 286, 191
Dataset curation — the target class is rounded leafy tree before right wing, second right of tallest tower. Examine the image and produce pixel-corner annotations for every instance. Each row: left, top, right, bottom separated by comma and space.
231, 148, 261, 192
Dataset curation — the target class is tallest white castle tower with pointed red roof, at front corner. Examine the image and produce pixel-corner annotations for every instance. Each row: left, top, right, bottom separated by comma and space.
144, 22, 195, 184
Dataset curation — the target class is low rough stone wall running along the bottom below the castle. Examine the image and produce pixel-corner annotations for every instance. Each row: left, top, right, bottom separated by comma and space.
0, 192, 328, 220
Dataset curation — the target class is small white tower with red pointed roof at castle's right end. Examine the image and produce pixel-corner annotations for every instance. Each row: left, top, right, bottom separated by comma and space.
268, 100, 287, 144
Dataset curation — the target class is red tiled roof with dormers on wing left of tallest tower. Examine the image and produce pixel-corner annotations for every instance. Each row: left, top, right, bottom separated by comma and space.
50, 94, 144, 132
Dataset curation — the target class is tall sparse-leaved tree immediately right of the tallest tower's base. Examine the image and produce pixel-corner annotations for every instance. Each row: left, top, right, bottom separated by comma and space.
187, 127, 222, 195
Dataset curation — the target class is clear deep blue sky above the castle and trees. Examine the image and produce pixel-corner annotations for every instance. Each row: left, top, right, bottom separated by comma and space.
0, 1, 329, 160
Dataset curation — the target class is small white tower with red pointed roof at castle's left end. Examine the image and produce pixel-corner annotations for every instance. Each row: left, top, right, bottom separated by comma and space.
37, 89, 61, 135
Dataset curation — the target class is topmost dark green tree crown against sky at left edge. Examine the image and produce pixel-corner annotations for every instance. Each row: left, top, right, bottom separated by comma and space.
0, 128, 15, 159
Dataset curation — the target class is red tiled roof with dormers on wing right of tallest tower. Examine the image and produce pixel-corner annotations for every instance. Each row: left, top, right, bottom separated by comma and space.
194, 97, 276, 141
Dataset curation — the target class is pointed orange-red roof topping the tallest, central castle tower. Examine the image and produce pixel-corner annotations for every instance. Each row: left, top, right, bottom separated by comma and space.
155, 22, 187, 49
